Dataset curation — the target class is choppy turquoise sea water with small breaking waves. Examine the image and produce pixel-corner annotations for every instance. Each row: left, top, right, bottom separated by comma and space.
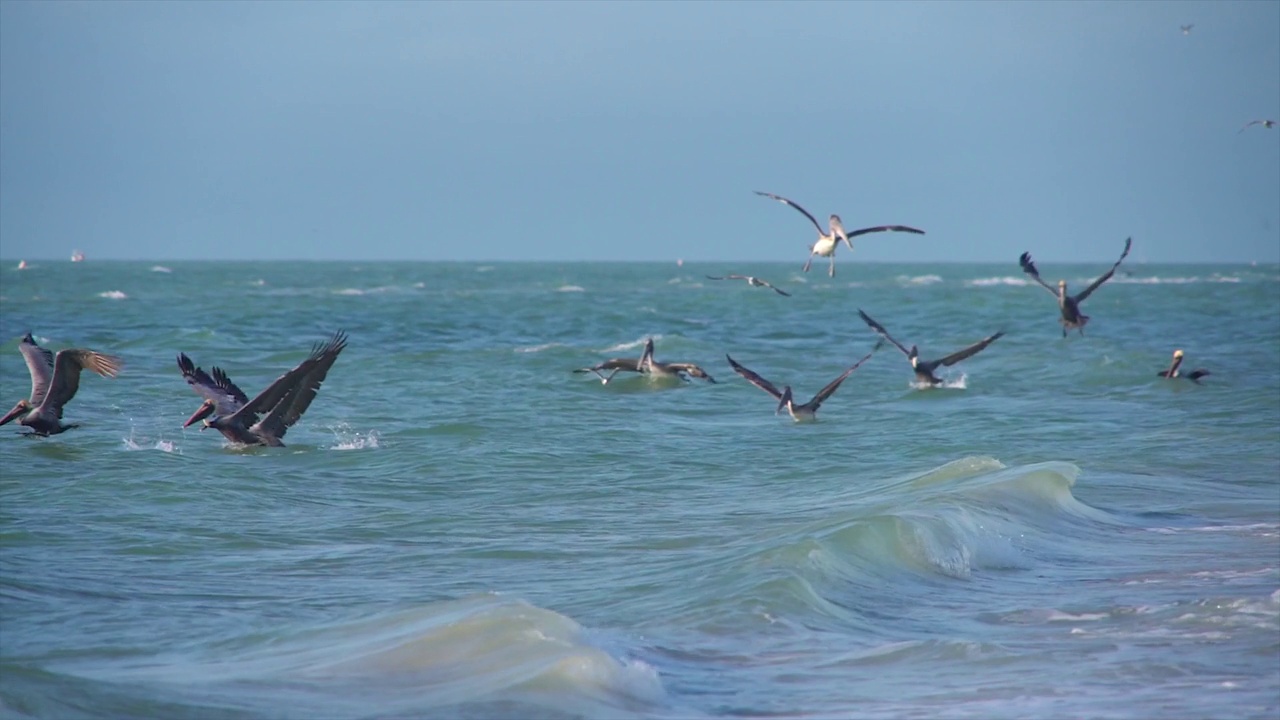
0, 256, 1280, 719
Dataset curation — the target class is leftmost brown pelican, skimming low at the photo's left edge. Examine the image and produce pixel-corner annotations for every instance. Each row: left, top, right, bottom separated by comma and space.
0, 333, 120, 436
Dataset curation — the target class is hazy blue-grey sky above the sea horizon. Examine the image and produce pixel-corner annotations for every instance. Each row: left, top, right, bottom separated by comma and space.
0, 0, 1280, 263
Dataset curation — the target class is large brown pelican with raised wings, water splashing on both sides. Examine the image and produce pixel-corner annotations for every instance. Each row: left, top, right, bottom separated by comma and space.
178, 331, 347, 447
